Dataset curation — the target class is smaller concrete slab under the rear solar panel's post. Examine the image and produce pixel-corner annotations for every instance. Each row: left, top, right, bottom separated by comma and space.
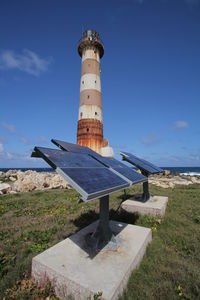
121, 196, 168, 217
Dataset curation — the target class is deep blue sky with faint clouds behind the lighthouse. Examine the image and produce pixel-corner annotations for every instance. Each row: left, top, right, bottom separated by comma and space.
0, 0, 200, 168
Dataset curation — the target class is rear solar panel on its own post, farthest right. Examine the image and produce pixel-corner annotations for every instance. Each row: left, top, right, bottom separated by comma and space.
120, 152, 164, 174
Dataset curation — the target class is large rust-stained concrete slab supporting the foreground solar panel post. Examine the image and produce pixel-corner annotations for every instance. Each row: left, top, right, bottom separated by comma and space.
32, 221, 152, 300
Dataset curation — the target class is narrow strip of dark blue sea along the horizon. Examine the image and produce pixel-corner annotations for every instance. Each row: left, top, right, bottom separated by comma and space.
0, 167, 200, 176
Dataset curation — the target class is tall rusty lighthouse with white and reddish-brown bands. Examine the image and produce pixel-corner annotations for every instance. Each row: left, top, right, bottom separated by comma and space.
77, 29, 113, 157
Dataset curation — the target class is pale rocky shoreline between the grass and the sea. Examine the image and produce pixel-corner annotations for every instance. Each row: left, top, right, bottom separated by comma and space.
0, 170, 200, 195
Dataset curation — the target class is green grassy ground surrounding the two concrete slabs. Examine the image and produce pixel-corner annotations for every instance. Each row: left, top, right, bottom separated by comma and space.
0, 185, 200, 300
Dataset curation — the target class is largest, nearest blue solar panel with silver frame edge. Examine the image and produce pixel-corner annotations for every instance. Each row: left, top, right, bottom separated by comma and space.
34, 147, 129, 201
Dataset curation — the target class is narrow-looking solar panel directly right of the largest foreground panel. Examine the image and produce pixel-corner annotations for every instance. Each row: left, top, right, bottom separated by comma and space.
92, 154, 147, 185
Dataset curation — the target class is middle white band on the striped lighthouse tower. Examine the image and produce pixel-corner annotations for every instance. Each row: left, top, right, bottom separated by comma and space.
80, 73, 101, 92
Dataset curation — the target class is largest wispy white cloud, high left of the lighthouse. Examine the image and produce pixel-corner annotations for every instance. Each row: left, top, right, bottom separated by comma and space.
0, 49, 52, 76
